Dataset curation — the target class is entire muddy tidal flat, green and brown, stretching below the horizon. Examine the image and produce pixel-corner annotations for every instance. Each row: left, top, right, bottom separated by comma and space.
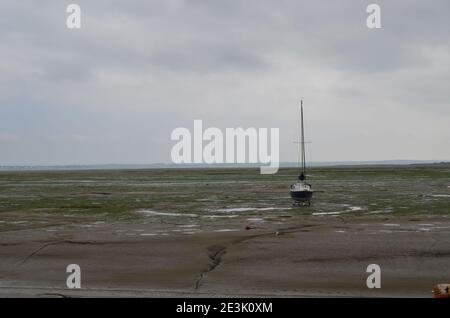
0, 166, 450, 297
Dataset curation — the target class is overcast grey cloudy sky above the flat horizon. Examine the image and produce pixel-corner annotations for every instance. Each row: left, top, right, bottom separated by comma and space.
0, 0, 450, 165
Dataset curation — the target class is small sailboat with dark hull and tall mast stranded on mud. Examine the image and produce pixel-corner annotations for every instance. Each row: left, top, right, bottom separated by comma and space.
291, 100, 313, 206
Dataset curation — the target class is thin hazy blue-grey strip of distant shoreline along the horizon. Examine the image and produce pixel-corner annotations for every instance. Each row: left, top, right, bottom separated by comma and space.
0, 160, 450, 172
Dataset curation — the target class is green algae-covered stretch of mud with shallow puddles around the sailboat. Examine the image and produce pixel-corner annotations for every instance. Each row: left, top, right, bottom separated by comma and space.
0, 165, 450, 231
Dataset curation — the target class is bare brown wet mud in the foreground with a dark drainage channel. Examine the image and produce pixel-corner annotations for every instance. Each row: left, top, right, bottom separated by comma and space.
0, 216, 450, 297
